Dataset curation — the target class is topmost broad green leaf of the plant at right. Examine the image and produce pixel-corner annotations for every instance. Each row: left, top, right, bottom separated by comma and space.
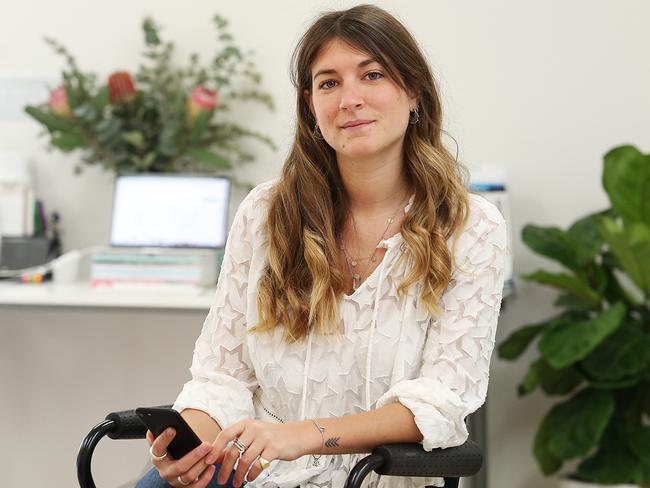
603, 146, 650, 226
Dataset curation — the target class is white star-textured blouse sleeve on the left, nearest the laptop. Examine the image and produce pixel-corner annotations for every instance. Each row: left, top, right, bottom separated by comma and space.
173, 185, 266, 428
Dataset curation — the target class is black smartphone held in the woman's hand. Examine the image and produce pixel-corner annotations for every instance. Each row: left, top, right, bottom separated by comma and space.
135, 407, 201, 459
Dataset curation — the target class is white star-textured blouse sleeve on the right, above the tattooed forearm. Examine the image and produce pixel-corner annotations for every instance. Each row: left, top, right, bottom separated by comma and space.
377, 199, 508, 451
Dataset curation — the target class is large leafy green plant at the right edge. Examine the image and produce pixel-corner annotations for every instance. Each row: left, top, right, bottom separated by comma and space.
498, 146, 650, 487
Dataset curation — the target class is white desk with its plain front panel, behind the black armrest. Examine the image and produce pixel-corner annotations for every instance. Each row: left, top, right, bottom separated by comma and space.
0, 282, 214, 488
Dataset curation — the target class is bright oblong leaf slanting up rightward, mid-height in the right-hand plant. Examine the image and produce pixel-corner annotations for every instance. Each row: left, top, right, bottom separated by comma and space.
538, 303, 625, 369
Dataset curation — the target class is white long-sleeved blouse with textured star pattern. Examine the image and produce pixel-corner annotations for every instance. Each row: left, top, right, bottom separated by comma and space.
174, 181, 508, 488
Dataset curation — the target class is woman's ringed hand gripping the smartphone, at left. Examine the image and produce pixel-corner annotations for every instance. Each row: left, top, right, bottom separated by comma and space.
147, 427, 215, 488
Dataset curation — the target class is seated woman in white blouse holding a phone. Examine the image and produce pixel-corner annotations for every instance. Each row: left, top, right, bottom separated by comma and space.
139, 5, 506, 487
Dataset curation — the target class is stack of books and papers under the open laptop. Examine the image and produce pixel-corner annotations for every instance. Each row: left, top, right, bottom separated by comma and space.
90, 249, 217, 287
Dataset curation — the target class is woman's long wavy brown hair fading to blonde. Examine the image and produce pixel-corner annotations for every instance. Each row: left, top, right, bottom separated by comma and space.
253, 5, 469, 342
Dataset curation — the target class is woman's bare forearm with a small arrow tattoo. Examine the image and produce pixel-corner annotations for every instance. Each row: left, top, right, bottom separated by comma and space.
296, 402, 422, 455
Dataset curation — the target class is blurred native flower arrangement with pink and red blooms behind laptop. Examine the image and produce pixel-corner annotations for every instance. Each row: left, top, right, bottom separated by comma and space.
25, 15, 274, 174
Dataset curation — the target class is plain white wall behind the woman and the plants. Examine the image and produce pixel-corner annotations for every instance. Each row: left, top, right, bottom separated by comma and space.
0, 0, 650, 488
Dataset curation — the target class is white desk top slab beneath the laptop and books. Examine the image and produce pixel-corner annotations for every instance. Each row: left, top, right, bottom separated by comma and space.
0, 282, 216, 312
